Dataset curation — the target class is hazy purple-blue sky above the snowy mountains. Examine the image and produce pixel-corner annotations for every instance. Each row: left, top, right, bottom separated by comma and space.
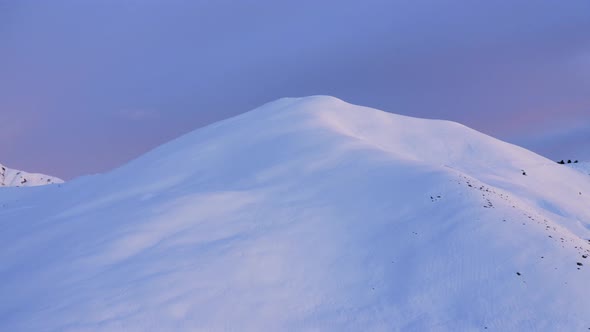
0, 0, 590, 179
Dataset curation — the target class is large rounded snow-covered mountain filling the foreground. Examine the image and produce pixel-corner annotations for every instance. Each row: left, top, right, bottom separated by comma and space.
0, 96, 590, 331
